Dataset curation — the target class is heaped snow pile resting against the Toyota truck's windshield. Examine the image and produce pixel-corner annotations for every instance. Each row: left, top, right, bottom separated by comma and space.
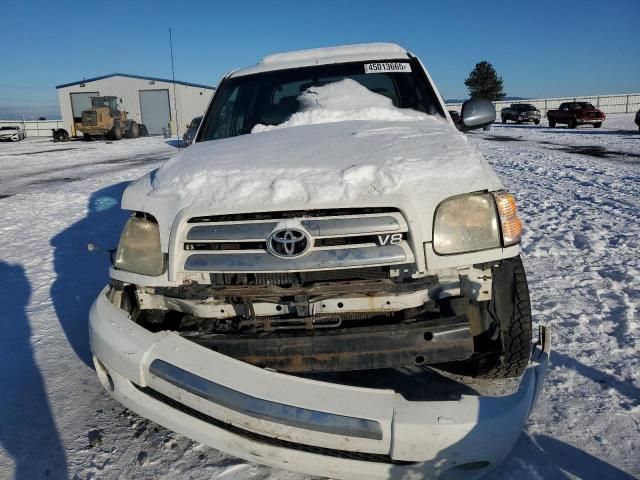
252, 78, 428, 133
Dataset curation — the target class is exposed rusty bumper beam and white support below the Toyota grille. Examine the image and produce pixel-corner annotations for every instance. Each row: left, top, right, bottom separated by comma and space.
109, 268, 474, 372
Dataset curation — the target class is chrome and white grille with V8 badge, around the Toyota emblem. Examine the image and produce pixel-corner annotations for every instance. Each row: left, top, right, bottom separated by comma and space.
175, 209, 414, 273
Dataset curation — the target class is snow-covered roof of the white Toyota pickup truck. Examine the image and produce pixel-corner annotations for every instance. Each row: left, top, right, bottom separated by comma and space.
231, 43, 408, 77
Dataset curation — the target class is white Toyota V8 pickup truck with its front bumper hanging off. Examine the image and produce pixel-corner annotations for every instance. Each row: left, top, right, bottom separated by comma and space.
90, 44, 552, 478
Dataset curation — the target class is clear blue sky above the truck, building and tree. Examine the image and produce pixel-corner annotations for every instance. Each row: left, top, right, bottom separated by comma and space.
0, 0, 640, 115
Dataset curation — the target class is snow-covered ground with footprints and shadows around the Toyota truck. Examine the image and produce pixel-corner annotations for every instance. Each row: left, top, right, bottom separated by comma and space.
0, 115, 640, 480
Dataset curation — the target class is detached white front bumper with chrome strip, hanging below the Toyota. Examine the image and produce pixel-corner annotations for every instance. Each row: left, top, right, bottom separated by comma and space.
90, 289, 549, 479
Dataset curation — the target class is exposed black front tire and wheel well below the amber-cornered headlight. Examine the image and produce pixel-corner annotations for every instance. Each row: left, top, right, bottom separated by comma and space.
437, 256, 532, 378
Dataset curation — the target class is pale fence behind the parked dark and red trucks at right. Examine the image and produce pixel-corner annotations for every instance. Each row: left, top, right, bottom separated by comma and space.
447, 93, 640, 117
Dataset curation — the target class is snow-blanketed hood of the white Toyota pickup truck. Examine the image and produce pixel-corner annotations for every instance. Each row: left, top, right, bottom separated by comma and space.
122, 117, 501, 248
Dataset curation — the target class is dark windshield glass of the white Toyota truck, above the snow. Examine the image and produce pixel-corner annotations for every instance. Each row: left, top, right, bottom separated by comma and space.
198, 60, 444, 141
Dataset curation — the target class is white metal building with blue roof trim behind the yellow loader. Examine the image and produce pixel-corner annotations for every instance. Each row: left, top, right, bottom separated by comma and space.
56, 73, 215, 136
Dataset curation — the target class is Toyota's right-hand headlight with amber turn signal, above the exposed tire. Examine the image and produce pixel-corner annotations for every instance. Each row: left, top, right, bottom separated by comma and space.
433, 191, 522, 255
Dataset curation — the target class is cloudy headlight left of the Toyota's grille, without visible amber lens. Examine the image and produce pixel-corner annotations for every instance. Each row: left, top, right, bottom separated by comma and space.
113, 214, 165, 277
